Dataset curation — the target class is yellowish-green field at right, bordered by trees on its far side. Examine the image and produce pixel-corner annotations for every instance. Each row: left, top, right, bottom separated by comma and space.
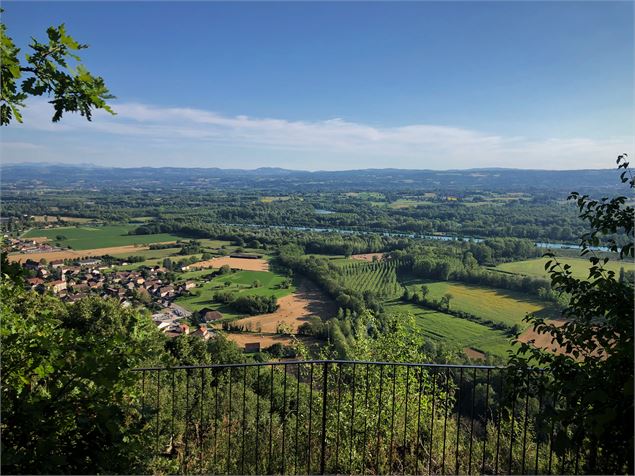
408, 281, 558, 327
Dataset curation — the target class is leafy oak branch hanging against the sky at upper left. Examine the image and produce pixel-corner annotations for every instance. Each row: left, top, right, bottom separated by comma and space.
0, 14, 114, 126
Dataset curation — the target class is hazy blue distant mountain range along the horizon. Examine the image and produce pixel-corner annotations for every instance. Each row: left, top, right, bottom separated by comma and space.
0, 163, 620, 193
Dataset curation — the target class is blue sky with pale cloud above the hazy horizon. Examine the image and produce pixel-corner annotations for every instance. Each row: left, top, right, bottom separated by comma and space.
0, 1, 635, 170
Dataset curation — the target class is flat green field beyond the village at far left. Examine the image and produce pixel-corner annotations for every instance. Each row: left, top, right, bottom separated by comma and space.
24, 225, 180, 250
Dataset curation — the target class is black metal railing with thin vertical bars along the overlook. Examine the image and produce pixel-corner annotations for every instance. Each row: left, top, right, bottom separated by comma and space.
136, 360, 584, 474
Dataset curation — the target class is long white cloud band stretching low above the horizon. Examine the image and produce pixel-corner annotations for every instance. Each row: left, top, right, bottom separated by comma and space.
7, 101, 633, 169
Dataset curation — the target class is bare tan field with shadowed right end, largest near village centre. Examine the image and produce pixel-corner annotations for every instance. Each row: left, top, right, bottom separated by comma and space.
233, 281, 337, 334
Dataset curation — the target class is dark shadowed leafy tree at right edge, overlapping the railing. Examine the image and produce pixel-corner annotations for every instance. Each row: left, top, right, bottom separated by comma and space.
510, 155, 635, 474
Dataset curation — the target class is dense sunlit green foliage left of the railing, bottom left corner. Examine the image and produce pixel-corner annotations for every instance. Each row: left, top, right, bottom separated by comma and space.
0, 281, 161, 474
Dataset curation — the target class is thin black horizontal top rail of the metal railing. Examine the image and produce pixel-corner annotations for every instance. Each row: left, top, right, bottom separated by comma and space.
132, 360, 520, 372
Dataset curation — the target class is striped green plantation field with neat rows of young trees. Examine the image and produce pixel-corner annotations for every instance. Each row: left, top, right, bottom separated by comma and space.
342, 261, 402, 298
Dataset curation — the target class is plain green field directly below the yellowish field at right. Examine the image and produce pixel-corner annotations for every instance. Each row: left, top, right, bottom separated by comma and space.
386, 302, 511, 357
